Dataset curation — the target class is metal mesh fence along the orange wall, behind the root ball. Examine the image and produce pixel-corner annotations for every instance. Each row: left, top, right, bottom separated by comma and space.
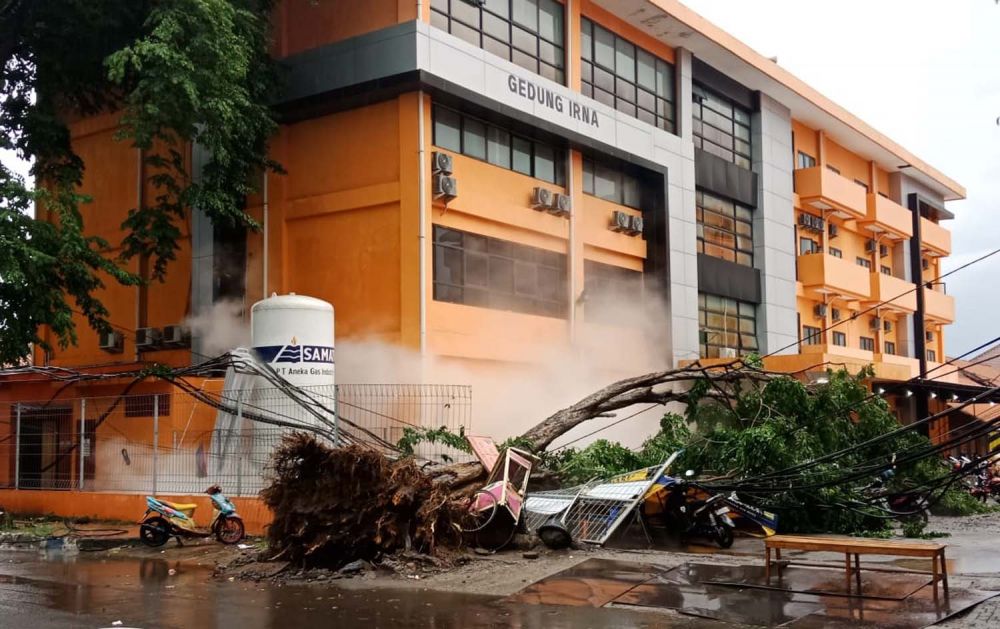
0, 385, 472, 496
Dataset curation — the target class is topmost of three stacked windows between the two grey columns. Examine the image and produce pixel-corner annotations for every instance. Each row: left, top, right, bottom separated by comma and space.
691, 84, 751, 169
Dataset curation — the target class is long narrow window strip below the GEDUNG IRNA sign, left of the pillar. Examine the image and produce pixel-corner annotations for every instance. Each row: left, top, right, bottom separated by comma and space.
433, 105, 566, 186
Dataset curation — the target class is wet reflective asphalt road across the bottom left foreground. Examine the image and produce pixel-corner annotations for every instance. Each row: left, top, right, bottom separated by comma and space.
0, 551, 712, 629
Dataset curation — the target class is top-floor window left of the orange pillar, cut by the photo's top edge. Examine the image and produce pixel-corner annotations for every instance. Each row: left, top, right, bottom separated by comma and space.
431, 0, 565, 83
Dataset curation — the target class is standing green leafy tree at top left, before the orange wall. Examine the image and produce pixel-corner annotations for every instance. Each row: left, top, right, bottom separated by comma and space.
0, 0, 278, 364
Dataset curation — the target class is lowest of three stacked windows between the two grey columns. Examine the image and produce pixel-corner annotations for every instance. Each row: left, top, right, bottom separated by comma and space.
698, 293, 757, 358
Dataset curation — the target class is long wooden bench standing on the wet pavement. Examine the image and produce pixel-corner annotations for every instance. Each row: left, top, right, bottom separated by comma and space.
764, 535, 948, 596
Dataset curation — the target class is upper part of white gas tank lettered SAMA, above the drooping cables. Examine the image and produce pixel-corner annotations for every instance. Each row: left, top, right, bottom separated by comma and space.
250, 293, 335, 387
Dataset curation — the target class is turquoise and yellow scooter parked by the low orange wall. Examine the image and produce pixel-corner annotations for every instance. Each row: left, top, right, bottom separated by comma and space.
139, 485, 246, 547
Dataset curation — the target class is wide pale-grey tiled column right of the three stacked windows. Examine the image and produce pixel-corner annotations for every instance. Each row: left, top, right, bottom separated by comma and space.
751, 94, 798, 354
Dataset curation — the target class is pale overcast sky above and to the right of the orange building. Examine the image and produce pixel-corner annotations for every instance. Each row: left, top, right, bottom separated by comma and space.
682, 0, 1000, 356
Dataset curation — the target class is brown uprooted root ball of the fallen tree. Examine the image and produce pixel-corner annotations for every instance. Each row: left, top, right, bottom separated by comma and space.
261, 433, 468, 567
